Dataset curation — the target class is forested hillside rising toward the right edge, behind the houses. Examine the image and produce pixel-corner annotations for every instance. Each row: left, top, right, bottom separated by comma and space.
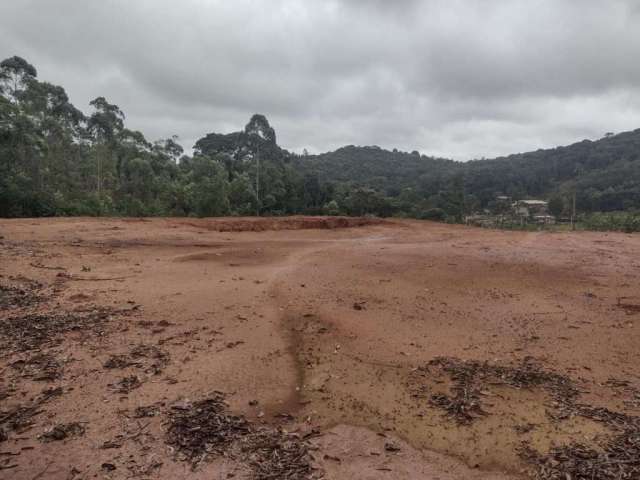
464, 129, 640, 211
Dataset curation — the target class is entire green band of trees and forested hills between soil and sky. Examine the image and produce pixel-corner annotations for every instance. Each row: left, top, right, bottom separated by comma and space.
0, 57, 640, 221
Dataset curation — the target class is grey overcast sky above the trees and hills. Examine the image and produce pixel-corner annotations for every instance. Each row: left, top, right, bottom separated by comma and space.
0, 0, 640, 160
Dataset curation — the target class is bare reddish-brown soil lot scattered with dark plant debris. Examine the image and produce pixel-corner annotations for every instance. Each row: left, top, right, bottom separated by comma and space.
0, 217, 640, 480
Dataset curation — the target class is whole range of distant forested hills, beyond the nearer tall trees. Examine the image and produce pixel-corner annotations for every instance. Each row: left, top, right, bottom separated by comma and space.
296, 129, 640, 216
